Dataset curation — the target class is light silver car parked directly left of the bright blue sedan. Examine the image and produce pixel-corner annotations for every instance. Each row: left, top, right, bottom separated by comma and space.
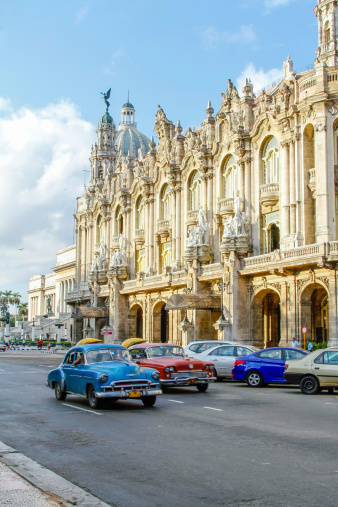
199, 343, 258, 379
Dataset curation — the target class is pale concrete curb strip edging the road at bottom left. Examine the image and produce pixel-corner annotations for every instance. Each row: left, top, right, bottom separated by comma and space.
0, 441, 117, 507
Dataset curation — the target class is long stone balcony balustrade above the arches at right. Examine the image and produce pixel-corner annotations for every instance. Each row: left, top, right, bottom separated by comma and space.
240, 241, 338, 275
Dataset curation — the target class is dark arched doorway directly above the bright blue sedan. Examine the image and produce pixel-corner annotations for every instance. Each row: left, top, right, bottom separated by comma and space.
252, 289, 281, 348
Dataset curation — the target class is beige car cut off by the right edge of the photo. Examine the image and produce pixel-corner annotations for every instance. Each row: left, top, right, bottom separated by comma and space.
284, 347, 338, 394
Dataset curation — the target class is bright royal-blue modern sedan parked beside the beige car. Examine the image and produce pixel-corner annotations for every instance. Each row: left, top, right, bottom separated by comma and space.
232, 347, 307, 387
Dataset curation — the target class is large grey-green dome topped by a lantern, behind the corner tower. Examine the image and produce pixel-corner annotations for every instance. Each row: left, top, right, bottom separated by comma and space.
115, 101, 150, 158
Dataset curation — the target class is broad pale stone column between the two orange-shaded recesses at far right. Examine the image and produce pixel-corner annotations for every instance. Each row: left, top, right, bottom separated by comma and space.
315, 122, 333, 243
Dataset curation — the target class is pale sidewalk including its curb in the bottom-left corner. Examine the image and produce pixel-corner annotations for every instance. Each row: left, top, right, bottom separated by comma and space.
0, 441, 116, 507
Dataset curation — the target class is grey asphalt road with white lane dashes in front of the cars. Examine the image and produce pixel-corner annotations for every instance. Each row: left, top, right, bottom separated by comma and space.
0, 352, 338, 507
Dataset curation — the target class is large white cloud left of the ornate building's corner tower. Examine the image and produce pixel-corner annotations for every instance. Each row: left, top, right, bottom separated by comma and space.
0, 98, 95, 301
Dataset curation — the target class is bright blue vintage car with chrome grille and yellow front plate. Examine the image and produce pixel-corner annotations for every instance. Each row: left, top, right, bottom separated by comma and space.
46, 343, 162, 409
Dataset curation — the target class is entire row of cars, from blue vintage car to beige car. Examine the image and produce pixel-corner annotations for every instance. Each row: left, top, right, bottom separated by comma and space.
46, 342, 338, 409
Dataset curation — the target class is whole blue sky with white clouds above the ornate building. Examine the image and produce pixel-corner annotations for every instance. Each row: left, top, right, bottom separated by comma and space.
0, 0, 318, 302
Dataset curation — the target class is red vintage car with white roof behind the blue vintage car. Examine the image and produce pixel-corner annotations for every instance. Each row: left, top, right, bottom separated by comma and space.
128, 343, 216, 392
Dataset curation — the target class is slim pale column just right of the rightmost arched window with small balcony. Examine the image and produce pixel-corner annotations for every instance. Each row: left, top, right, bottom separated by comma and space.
280, 141, 290, 241
